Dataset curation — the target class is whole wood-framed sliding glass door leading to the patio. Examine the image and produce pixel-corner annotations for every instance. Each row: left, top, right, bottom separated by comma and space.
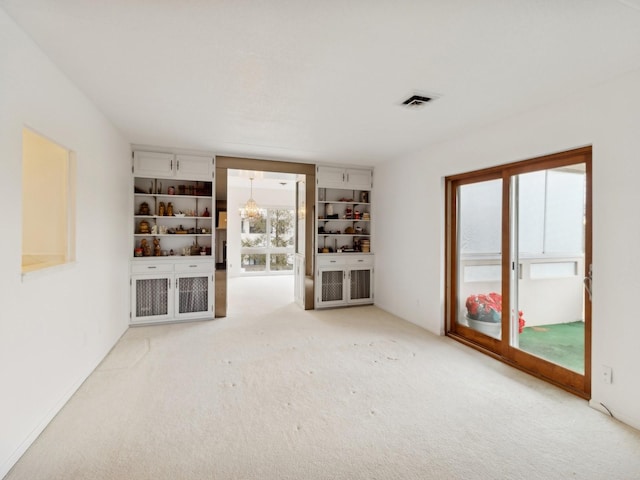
447, 148, 591, 397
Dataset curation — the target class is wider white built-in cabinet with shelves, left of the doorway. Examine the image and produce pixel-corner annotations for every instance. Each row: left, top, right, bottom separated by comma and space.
130, 151, 215, 324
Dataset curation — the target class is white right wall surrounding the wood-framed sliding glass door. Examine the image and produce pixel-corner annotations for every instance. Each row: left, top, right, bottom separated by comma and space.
375, 71, 640, 428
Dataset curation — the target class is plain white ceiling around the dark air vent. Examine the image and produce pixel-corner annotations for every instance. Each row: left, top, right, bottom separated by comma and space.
0, 0, 640, 165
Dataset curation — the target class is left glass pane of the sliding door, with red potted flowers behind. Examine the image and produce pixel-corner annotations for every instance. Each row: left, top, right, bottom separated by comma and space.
456, 179, 502, 339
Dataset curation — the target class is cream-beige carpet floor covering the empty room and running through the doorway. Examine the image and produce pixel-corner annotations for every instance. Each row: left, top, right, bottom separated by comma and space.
6, 279, 640, 480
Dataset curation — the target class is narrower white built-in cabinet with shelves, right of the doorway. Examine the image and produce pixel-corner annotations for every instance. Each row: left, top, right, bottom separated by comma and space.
315, 166, 374, 308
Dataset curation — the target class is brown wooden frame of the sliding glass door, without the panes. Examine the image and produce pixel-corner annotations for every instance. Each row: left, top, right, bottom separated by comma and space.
445, 146, 593, 399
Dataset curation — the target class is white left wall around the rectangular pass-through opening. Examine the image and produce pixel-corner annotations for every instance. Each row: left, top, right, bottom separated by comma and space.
0, 9, 130, 477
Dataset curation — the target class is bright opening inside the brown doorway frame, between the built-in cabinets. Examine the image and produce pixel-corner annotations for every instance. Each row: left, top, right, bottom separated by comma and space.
225, 169, 296, 314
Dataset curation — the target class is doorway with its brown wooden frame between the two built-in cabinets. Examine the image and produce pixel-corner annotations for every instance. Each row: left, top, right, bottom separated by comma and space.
216, 157, 315, 317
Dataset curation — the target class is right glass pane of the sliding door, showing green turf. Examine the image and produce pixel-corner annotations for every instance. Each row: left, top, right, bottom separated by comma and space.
510, 164, 586, 374
